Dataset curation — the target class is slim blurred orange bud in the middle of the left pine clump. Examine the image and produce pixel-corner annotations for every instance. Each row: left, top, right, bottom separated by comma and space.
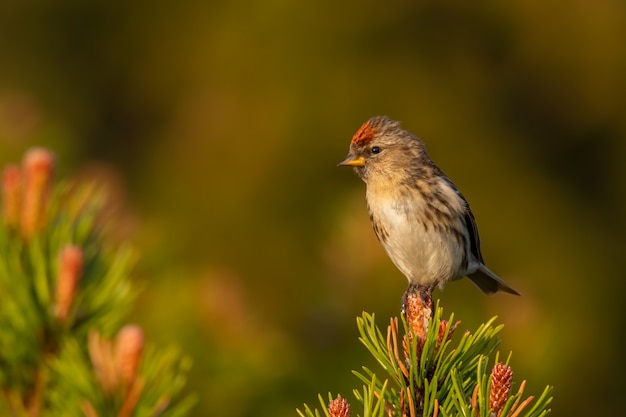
55, 245, 83, 321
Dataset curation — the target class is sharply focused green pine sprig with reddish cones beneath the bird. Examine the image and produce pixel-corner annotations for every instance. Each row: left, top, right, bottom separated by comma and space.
298, 304, 552, 417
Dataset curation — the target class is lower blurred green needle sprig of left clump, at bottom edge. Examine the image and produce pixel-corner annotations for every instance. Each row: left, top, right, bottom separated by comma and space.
49, 330, 196, 417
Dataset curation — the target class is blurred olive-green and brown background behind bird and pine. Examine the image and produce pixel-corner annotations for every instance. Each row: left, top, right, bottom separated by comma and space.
0, 0, 626, 417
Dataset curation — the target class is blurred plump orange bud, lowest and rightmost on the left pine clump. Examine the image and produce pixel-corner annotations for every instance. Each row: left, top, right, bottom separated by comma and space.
115, 324, 144, 385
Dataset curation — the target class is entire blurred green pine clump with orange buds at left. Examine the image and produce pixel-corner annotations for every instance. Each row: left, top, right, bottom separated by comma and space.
0, 148, 194, 417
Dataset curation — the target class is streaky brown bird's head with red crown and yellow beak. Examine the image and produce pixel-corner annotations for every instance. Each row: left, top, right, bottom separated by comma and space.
339, 116, 429, 182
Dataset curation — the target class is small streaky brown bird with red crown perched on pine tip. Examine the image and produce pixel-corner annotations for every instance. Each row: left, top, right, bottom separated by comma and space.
339, 116, 519, 295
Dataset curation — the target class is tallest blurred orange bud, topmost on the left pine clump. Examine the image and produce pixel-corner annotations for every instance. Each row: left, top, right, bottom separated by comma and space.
22, 148, 54, 239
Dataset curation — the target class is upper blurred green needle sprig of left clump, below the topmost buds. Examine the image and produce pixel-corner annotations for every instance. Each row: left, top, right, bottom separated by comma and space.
0, 177, 136, 389
